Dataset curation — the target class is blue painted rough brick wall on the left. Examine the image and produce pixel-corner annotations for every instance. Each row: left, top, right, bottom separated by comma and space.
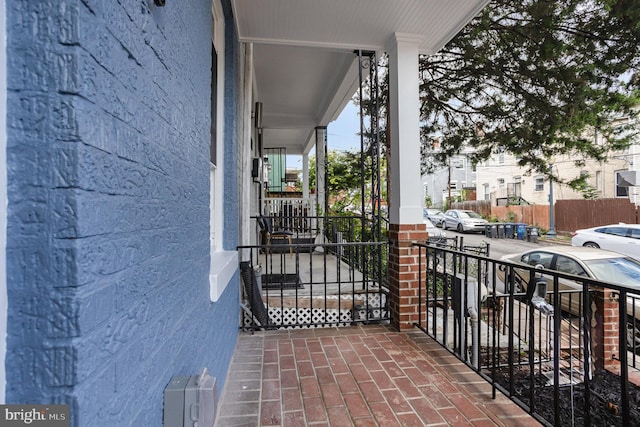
6, 0, 239, 427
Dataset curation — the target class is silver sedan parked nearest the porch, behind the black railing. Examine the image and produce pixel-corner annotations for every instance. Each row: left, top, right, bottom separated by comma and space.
496, 245, 640, 348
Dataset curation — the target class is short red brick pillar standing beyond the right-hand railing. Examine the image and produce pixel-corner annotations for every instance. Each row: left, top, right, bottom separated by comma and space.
591, 288, 620, 369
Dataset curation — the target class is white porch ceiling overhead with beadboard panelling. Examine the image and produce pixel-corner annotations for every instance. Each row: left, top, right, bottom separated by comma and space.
232, 0, 488, 154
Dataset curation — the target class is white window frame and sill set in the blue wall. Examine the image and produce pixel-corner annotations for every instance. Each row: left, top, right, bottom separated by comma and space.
209, 0, 238, 302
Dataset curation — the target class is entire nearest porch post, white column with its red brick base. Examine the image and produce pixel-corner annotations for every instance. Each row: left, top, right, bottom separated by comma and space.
387, 34, 427, 330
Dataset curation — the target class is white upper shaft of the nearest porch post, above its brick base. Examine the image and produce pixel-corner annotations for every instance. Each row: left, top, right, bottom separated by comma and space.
387, 33, 422, 224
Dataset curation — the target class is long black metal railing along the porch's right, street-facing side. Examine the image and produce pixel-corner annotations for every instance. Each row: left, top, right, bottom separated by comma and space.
416, 244, 640, 426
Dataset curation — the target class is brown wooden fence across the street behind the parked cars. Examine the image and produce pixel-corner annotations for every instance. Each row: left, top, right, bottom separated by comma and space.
452, 199, 640, 233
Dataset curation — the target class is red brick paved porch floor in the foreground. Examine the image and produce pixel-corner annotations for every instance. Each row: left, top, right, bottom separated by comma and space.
216, 326, 540, 427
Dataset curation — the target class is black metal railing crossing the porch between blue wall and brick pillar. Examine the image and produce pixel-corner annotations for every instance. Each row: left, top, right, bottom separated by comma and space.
238, 239, 389, 329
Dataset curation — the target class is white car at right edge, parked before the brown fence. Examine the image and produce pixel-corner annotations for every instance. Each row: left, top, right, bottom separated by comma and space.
571, 223, 640, 260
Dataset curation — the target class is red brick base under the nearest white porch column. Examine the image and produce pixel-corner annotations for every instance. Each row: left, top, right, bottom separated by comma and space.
389, 224, 427, 331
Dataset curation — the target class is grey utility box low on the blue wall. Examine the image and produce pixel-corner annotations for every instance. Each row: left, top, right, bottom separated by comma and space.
163, 369, 218, 427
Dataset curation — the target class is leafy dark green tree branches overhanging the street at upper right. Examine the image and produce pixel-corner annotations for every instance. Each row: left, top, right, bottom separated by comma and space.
420, 0, 640, 186
